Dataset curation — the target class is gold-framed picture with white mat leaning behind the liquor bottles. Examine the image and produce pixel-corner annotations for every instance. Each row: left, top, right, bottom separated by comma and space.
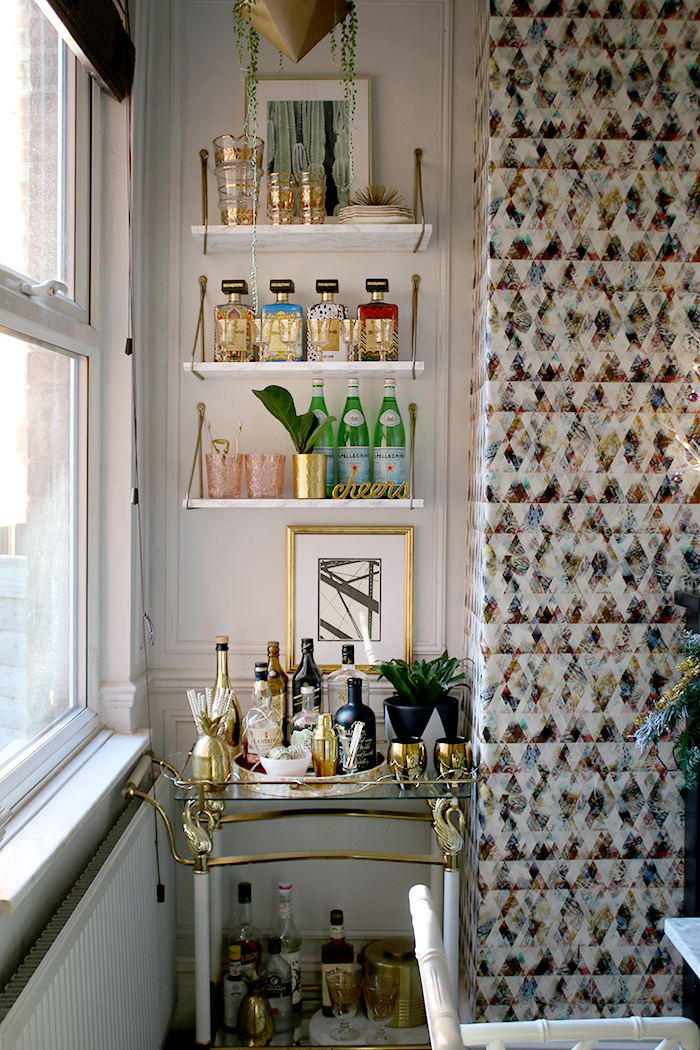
287, 525, 413, 671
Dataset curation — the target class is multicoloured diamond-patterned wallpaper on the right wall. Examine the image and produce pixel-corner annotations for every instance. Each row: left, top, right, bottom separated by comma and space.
476, 0, 700, 1020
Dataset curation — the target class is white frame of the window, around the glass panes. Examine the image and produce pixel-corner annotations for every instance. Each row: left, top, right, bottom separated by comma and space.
0, 37, 101, 839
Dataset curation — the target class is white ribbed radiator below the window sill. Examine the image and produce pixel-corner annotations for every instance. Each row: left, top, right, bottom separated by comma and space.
0, 776, 175, 1050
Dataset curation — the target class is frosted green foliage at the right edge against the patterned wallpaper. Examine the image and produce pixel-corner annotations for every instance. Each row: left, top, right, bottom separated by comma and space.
635, 631, 700, 786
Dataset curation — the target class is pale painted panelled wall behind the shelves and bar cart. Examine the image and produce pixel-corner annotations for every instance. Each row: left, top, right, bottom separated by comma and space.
136, 0, 473, 1023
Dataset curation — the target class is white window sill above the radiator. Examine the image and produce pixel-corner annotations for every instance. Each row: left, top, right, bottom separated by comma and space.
0, 730, 149, 916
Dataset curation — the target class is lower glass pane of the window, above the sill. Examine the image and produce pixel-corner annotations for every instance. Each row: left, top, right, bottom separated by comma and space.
0, 333, 78, 765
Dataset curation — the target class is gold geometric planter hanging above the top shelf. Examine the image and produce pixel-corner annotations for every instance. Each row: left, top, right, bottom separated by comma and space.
239, 0, 349, 62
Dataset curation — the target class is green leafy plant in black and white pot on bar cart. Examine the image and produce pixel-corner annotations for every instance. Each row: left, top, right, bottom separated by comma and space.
379, 649, 465, 776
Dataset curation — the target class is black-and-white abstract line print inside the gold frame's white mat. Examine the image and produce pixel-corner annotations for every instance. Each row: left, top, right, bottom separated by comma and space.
318, 558, 382, 642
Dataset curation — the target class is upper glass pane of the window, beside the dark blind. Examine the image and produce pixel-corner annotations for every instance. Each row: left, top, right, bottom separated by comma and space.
0, 0, 66, 281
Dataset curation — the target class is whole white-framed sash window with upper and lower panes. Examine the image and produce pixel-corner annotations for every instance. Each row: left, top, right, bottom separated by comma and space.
0, 0, 97, 825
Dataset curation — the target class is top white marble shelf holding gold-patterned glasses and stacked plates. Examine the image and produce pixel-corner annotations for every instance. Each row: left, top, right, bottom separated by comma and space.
192, 223, 432, 255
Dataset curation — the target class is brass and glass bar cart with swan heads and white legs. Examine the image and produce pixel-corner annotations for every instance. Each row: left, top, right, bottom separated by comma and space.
123, 755, 475, 1047
